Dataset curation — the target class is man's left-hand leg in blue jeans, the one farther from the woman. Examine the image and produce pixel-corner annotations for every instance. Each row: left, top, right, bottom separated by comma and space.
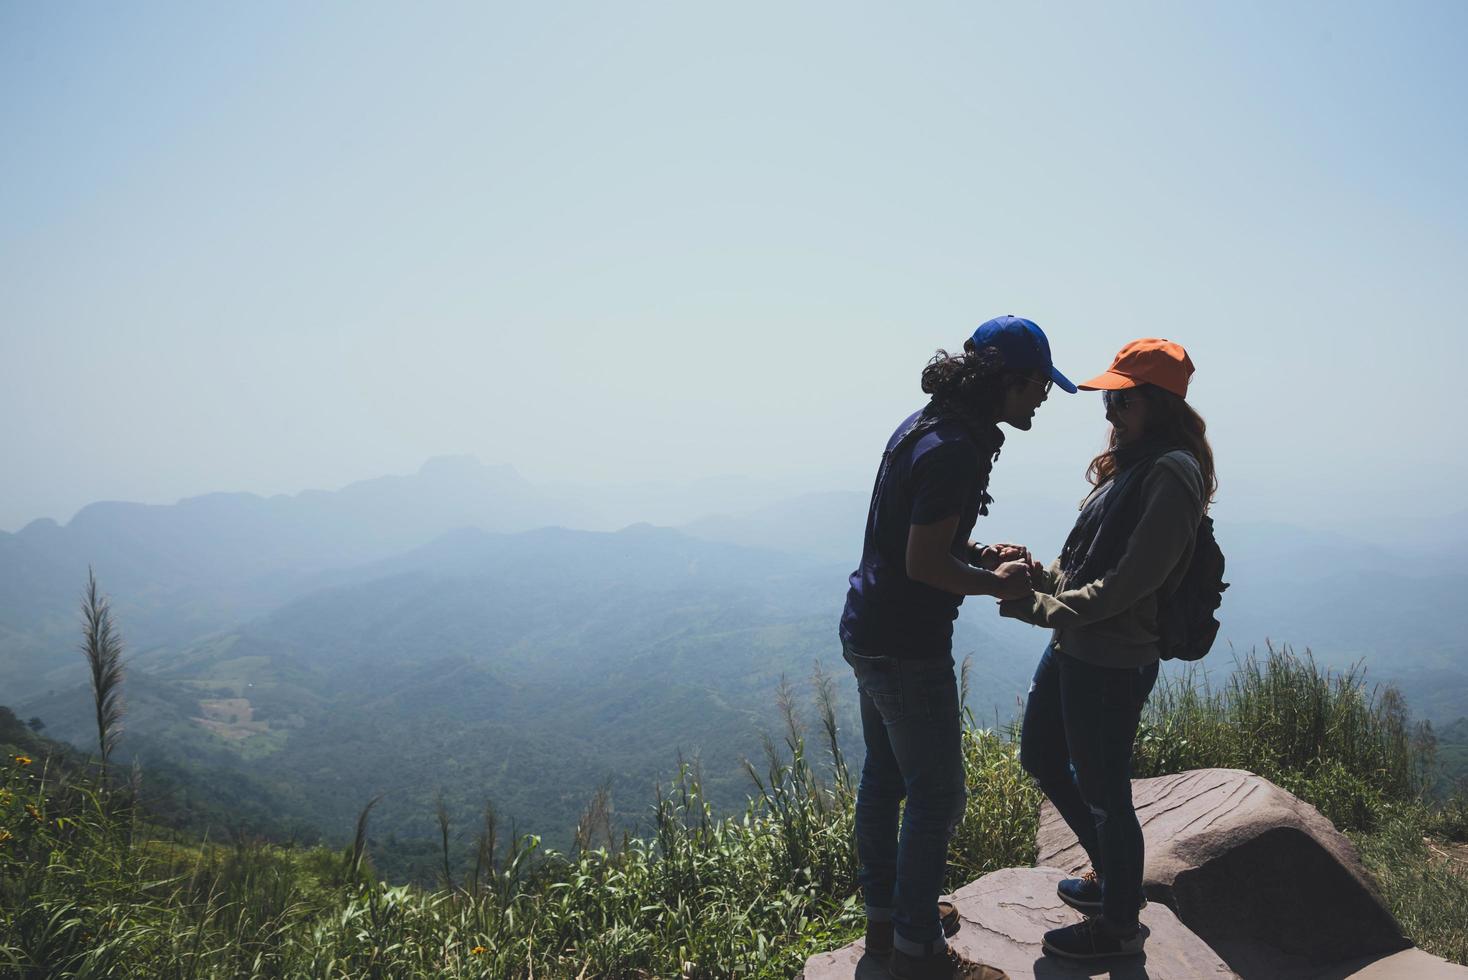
843, 647, 906, 923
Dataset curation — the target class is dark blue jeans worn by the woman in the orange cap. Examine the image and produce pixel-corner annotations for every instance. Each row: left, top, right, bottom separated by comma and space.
1019, 646, 1157, 932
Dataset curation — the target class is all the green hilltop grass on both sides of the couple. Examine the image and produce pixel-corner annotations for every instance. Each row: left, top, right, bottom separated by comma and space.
0, 650, 1468, 980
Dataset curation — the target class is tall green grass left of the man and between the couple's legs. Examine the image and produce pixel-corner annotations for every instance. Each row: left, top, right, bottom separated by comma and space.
0, 666, 1038, 980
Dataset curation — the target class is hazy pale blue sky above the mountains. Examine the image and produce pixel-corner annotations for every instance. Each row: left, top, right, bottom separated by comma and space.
0, 0, 1468, 533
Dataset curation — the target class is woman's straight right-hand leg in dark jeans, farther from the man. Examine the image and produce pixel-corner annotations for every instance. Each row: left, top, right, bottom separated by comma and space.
1060, 659, 1157, 933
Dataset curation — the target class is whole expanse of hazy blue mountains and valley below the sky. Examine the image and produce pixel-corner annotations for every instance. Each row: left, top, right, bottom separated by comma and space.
0, 458, 1468, 874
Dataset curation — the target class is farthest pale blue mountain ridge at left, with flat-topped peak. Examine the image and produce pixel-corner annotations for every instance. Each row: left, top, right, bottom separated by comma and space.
0, 456, 810, 692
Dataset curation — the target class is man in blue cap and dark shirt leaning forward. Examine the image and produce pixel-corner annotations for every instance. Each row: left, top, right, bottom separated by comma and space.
841, 317, 1076, 980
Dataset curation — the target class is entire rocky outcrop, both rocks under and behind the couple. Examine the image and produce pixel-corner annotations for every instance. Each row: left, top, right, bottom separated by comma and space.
803, 769, 1468, 980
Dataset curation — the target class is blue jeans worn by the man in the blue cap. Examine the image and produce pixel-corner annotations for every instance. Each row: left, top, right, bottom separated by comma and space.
841, 644, 967, 957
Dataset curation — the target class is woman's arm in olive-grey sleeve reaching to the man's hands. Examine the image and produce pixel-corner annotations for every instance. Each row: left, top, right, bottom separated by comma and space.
1000, 461, 1202, 629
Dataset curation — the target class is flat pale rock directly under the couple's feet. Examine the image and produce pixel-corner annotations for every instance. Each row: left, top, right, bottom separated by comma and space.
804, 867, 1236, 980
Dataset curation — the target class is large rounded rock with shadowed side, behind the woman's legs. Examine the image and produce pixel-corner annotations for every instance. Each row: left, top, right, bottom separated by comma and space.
1036, 769, 1411, 977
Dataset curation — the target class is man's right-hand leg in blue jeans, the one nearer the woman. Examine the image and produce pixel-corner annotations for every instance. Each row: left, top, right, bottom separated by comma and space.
884, 657, 967, 957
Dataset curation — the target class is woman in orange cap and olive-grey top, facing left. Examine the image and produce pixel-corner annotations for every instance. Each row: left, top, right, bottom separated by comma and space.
1000, 339, 1217, 959
